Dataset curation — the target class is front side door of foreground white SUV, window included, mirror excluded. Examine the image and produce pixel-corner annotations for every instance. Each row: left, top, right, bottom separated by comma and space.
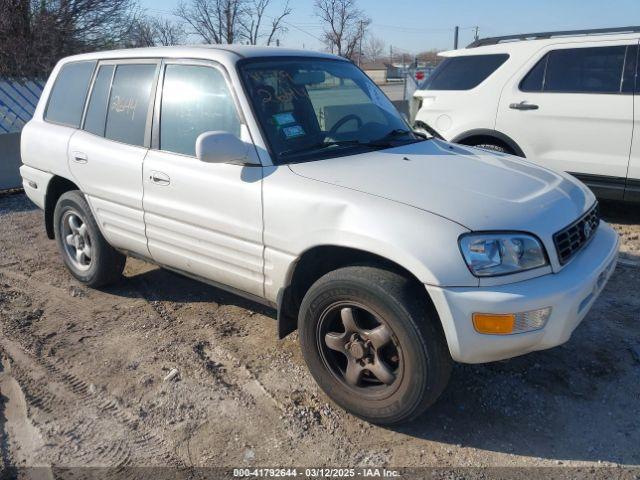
143, 61, 264, 296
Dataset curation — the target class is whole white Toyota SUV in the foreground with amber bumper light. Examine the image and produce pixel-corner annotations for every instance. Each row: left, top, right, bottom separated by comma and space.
21, 46, 618, 424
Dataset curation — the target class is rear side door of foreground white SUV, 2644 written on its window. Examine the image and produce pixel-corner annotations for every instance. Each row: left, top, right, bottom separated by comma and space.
68, 60, 159, 255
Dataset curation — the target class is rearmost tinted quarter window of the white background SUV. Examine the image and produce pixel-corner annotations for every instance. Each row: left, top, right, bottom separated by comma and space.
425, 54, 509, 90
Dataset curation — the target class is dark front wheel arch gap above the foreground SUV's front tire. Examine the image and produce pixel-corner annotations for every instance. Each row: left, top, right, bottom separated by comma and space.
277, 245, 442, 338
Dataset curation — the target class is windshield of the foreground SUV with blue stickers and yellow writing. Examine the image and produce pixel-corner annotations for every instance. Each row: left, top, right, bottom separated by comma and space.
239, 57, 424, 163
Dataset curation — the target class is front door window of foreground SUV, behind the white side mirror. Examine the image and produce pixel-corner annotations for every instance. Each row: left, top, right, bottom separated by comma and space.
160, 65, 240, 156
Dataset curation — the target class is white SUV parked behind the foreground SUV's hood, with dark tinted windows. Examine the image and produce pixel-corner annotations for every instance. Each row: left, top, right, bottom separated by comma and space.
412, 27, 640, 201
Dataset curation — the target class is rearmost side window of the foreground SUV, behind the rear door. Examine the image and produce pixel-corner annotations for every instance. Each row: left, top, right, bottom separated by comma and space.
44, 62, 96, 128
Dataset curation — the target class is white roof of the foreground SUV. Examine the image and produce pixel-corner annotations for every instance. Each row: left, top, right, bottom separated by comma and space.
57, 44, 344, 61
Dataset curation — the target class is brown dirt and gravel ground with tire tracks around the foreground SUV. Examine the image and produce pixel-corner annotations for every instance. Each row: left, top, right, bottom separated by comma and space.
0, 194, 640, 470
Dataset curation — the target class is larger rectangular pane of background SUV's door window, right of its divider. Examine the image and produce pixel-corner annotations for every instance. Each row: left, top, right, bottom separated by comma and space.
544, 46, 627, 93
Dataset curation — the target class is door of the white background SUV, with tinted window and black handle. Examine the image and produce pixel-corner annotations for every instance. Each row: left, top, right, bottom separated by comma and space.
496, 41, 637, 199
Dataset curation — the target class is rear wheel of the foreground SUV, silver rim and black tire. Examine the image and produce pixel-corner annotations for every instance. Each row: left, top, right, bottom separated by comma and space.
53, 190, 127, 288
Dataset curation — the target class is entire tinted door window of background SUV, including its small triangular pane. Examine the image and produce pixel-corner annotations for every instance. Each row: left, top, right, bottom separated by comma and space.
520, 45, 637, 93
